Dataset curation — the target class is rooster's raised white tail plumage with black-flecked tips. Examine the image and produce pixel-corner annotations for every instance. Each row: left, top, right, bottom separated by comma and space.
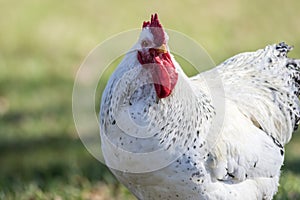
218, 42, 300, 144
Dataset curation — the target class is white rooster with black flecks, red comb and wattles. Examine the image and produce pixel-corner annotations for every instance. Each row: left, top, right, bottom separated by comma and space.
100, 14, 300, 200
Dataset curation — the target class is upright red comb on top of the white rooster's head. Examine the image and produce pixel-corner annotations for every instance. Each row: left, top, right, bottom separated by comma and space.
143, 13, 165, 46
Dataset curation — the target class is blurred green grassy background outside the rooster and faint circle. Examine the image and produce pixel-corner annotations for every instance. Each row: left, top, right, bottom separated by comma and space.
0, 0, 300, 200
